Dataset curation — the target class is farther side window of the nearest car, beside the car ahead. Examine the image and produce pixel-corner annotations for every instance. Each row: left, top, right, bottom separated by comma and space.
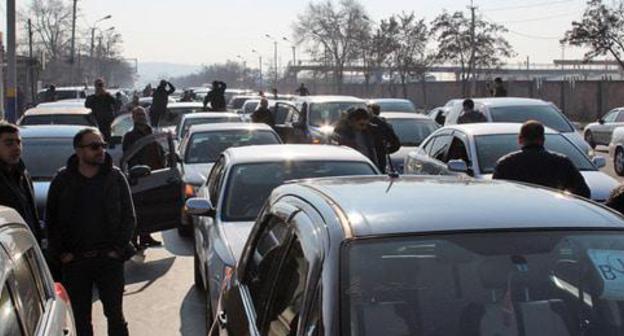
243, 217, 289, 328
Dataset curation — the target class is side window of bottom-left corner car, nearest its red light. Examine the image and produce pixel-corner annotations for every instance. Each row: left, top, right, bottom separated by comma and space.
13, 248, 44, 335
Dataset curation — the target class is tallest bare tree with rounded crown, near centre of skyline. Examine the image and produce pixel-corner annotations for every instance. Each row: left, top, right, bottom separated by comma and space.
294, 0, 371, 91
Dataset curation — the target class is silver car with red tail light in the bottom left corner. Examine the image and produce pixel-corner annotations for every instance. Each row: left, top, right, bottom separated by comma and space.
0, 206, 76, 336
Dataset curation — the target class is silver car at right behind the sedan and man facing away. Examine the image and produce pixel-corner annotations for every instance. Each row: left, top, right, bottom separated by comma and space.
445, 98, 593, 156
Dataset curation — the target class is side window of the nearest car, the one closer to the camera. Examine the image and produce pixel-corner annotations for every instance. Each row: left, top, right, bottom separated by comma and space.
264, 236, 309, 336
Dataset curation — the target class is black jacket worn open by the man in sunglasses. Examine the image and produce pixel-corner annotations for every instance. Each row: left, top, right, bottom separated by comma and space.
46, 154, 136, 258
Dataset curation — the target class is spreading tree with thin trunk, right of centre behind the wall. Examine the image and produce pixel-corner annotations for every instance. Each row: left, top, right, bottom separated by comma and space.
431, 12, 515, 96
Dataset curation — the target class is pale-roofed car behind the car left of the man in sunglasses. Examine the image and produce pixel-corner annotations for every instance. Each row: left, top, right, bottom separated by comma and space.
17, 104, 97, 126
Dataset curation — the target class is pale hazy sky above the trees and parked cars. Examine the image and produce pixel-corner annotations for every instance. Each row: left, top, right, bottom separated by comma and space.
18, 0, 596, 64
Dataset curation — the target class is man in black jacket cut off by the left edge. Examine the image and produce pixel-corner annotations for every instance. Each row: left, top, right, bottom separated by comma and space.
0, 122, 43, 243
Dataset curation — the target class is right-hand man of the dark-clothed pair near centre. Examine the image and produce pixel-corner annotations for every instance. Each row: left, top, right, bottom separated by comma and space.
368, 104, 401, 173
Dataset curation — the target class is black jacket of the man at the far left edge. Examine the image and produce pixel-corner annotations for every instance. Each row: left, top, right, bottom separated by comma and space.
0, 161, 43, 242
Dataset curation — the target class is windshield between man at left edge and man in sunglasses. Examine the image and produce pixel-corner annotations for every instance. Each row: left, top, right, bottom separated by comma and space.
22, 138, 74, 181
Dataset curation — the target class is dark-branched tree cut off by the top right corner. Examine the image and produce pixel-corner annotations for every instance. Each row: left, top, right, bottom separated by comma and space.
561, 0, 624, 69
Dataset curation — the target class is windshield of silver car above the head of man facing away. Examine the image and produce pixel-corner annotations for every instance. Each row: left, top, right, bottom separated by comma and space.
490, 105, 574, 132
